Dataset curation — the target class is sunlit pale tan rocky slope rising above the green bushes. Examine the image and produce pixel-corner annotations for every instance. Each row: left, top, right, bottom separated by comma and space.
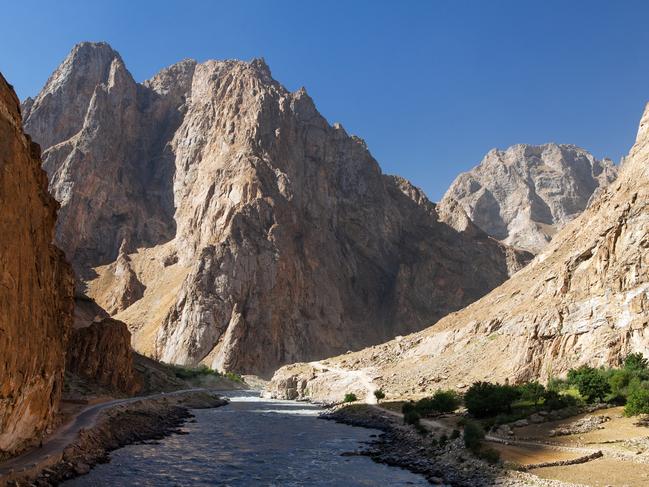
270, 105, 649, 400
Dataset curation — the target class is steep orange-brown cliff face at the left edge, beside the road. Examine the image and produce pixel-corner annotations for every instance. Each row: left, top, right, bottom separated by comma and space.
0, 75, 73, 455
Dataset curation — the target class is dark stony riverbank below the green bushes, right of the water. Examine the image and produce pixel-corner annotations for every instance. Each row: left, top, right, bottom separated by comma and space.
321, 404, 574, 487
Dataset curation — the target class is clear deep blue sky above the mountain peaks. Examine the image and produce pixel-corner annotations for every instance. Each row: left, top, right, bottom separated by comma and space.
0, 0, 649, 200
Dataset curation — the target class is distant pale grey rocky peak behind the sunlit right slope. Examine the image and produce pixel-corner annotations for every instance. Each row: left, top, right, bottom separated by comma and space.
440, 144, 617, 254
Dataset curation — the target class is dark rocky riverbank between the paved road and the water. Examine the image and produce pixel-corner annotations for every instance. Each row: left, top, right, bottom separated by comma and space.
0, 391, 228, 487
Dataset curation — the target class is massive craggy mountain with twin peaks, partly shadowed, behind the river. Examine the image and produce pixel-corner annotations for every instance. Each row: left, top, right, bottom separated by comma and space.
23, 43, 530, 375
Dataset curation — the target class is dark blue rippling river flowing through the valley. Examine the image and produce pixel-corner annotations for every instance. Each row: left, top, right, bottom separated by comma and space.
63, 391, 429, 487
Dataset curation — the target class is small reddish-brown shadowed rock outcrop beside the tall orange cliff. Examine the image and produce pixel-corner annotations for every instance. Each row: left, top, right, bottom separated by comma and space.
66, 297, 142, 394
